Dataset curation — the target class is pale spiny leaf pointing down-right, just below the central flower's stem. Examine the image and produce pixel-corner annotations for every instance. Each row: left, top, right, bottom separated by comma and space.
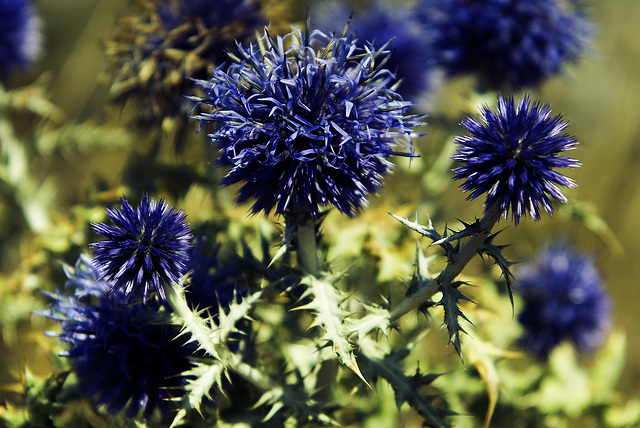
296, 276, 369, 385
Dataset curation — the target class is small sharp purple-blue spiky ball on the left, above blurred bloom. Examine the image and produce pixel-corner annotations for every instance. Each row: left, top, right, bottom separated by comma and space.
91, 195, 191, 302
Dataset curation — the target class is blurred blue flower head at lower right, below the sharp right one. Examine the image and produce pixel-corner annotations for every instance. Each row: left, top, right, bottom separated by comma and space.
516, 245, 611, 359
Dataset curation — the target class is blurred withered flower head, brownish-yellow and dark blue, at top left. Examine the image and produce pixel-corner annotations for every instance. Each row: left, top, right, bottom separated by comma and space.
106, 0, 266, 124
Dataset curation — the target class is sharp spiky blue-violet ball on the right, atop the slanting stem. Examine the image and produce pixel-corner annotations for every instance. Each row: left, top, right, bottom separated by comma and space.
452, 95, 580, 226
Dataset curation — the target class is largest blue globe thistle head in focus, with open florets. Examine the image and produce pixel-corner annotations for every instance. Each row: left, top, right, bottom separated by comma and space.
195, 29, 420, 218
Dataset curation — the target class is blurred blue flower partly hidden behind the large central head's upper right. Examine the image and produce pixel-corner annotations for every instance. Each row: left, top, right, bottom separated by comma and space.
312, 0, 431, 100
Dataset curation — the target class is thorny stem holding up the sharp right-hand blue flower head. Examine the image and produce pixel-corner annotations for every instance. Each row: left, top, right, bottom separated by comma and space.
389, 205, 501, 320
